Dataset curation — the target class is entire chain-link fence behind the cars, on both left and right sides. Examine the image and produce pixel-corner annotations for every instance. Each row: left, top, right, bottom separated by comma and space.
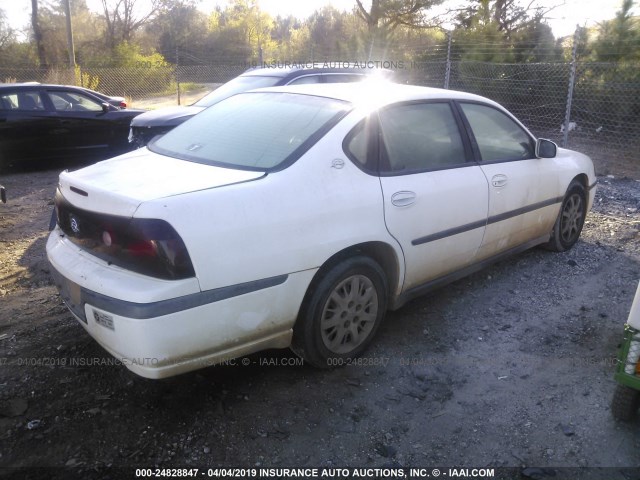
0, 61, 640, 174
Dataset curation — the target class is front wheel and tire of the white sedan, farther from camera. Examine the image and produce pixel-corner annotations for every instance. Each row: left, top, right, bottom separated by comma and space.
545, 181, 587, 252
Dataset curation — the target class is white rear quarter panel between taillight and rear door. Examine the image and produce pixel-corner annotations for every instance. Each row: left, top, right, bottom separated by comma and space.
135, 113, 403, 290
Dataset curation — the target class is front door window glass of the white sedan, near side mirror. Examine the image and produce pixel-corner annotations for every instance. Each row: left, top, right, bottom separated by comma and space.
460, 103, 535, 162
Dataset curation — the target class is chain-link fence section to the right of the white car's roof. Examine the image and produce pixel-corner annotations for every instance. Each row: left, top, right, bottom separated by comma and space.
442, 62, 640, 173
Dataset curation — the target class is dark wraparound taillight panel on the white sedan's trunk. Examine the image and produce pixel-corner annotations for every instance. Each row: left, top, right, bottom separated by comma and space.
56, 192, 195, 280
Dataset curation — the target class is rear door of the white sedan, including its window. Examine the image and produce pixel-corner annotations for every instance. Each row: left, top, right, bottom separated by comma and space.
372, 102, 488, 291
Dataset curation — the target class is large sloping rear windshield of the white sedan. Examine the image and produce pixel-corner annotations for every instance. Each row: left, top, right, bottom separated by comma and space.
149, 92, 350, 171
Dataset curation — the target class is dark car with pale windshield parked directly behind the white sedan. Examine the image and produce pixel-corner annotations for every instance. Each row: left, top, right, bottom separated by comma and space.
129, 62, 393, 148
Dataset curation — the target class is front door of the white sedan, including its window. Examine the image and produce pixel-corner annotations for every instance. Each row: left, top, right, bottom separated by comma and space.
459, 102, 562, 259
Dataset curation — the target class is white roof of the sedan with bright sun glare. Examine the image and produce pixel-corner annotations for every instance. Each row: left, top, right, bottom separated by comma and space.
253, 84, 500, 108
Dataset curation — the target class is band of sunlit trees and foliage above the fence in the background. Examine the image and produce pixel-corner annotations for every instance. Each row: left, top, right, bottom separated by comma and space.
0, 0, 640, 72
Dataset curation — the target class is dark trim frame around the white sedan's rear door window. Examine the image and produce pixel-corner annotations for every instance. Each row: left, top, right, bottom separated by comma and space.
375, 98, 477, 177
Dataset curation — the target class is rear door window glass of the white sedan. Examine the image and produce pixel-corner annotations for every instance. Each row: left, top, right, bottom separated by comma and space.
379, 103, 466, 174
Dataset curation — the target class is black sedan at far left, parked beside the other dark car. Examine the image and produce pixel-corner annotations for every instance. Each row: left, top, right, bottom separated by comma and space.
0, 83, 144, 170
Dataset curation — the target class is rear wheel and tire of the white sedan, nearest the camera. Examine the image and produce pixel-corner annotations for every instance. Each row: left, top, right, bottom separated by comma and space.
292, 256, 388, 368
